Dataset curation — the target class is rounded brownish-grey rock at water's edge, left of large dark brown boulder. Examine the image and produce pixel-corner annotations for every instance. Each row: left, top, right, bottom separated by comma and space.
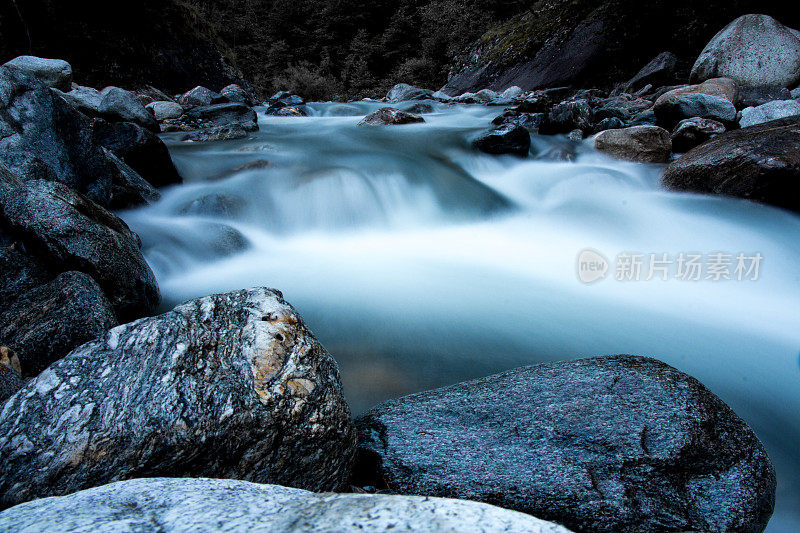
594, 126, 672, 163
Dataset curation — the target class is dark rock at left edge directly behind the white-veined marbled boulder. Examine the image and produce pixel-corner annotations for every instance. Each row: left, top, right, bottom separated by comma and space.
0, 272, 117, 377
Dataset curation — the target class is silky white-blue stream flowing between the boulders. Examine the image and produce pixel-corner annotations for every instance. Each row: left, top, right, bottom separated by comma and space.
122, 102, 800, 532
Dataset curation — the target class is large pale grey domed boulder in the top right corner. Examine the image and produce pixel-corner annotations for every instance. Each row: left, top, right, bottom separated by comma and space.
691, 15, 800, 87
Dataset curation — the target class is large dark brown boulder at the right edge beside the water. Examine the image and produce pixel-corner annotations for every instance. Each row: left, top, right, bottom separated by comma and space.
663, 117, 800, 212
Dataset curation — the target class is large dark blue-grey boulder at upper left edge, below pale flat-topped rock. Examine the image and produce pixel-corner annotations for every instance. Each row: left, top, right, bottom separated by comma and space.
0, 67, 136, 206
